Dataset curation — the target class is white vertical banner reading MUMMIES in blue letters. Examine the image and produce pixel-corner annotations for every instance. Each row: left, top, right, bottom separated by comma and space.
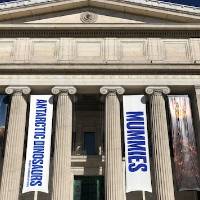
123, 95, 152, 192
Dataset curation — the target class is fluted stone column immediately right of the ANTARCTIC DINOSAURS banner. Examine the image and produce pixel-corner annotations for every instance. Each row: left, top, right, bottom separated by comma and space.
51, 86, 76, 200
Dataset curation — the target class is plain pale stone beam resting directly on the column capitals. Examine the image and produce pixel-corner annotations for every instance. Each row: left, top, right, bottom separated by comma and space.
0, 73, 197, 94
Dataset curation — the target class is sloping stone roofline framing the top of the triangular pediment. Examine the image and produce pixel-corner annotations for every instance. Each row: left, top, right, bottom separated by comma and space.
0, 0, 200, 23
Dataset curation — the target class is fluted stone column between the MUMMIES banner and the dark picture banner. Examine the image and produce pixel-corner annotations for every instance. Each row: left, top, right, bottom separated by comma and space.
146, 87, 175, 200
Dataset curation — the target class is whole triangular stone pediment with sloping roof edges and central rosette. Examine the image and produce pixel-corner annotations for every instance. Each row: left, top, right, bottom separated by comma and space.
0, 0, 200, 24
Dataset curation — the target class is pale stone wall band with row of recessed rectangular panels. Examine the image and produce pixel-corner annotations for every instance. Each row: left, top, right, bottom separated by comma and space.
0, 38, 200, 64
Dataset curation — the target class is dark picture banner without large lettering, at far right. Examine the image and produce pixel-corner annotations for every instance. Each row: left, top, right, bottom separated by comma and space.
168, 95, 200, 191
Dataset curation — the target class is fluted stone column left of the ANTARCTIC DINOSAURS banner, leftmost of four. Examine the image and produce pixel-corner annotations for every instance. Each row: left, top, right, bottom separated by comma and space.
0, 87, 31, 200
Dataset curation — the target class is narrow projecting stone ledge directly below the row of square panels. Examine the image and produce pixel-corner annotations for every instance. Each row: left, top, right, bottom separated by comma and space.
0, 62, 200, 72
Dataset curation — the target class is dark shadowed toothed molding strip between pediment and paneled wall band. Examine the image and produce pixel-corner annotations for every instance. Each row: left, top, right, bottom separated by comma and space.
0, 30, 200, 38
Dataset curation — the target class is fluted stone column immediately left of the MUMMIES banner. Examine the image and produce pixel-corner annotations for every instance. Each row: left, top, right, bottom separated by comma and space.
100, 87, 124, 200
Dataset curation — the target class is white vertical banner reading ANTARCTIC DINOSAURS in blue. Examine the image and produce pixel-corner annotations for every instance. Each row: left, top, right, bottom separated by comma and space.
22, 95, 53, 193
